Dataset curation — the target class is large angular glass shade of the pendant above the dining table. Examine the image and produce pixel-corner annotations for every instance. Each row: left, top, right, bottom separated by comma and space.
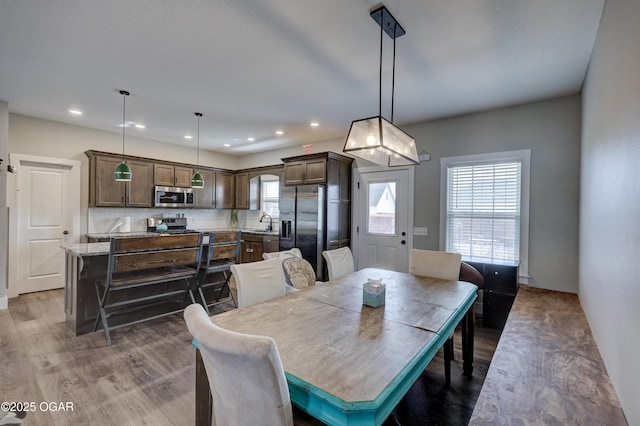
343, 116, 420, 167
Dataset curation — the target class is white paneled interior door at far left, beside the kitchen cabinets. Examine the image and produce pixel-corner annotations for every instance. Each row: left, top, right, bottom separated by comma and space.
15, 161, 79, 294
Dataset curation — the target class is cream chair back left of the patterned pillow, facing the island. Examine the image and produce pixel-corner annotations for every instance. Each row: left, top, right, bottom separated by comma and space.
231, 258, 287, 308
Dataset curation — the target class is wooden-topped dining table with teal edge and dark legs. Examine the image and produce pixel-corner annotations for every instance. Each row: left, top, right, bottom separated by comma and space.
194, 268, 478, 425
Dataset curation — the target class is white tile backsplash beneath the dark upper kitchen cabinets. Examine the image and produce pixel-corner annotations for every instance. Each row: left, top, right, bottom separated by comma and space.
87, 207, 278, 234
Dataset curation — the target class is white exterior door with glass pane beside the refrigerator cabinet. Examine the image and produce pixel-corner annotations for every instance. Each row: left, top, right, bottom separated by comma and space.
356, 169, 413, 272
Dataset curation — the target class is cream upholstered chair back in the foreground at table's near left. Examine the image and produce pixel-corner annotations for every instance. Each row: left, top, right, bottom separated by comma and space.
184, 304, 293, 426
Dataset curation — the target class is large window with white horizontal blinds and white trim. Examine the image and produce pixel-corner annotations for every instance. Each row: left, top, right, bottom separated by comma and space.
441, 150, 531, 271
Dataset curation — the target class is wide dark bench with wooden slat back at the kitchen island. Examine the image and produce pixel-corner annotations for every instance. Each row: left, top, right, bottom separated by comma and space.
93, 233, 202, 345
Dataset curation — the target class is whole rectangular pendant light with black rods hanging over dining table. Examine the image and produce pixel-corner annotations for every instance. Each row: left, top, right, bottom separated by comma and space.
342, 6, 420, 167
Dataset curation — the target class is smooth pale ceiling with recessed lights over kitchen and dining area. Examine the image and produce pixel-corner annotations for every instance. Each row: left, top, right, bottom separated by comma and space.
0, 0, 604, 155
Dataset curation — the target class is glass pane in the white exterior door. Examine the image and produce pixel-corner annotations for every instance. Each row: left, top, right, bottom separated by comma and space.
367, 181, 396, 235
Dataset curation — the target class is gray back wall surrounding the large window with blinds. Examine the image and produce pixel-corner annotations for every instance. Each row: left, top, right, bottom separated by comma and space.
403, 96, 581, 293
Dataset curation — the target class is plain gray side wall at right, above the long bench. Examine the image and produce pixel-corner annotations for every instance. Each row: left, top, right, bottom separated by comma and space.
579, 0, 640, 425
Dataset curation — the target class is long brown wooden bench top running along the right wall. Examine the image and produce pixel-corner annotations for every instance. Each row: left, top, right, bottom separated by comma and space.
469, 286, 627, 425
